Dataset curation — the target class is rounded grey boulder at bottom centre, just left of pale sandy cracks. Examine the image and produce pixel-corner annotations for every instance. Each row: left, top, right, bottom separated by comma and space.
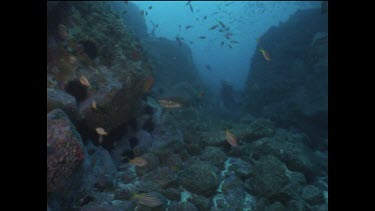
179, 163, 219, 196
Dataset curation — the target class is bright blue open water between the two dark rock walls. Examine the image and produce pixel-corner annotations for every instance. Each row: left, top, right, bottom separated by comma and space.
125, 1, 320, 91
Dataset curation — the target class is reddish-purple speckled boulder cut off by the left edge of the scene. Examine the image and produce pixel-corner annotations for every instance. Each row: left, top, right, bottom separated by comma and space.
47, 109, 85, 193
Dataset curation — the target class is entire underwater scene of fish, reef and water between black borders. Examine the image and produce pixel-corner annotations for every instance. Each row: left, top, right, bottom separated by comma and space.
47, 1, 328, 211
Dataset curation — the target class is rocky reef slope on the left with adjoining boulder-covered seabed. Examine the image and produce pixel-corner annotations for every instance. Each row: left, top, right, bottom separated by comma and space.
47, 2, 328, 211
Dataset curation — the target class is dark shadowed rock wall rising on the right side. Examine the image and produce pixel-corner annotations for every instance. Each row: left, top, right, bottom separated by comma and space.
244, 10, 328, 150
